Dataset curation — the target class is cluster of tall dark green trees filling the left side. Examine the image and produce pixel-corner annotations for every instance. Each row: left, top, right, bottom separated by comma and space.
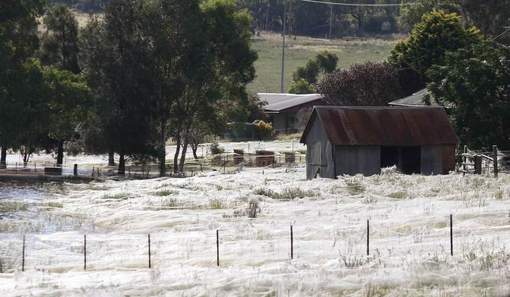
0, 0, 257, 175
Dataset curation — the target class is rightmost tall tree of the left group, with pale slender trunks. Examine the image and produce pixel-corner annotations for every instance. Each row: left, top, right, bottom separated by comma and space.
174, 0, 257, 172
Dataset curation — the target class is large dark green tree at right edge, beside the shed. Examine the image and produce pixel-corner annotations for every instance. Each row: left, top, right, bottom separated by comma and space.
428, 41, 510, 149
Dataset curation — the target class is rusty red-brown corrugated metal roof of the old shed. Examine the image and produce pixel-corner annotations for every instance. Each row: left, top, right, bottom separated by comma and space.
301, 106, 458, 146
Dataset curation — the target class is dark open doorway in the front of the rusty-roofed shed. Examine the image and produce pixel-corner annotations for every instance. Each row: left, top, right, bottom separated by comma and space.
381, 146, 421, 174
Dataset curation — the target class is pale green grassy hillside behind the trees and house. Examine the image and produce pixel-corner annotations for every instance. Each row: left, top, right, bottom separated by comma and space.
248, 33, 397, 94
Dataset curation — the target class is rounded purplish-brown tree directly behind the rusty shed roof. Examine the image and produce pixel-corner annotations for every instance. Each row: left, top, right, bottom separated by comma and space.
317, 62, 403, 106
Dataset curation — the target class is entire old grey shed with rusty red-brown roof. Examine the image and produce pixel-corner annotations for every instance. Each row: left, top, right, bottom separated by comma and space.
301, 106, 458, 179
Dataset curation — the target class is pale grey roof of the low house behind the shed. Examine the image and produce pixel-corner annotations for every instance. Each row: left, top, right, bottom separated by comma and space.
257, 93, 324, 113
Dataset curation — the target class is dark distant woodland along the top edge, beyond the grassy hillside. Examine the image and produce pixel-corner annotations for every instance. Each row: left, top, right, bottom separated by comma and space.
44, 0, 510, 42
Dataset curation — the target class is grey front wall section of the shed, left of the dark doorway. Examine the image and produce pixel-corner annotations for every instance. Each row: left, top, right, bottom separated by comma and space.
335, 146, 381, 176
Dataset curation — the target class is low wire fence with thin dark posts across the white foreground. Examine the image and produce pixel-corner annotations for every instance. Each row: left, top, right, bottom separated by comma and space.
0, 212, 510, 273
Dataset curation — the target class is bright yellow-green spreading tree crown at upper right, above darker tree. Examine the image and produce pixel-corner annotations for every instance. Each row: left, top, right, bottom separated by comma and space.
389, 11, 482, 80
